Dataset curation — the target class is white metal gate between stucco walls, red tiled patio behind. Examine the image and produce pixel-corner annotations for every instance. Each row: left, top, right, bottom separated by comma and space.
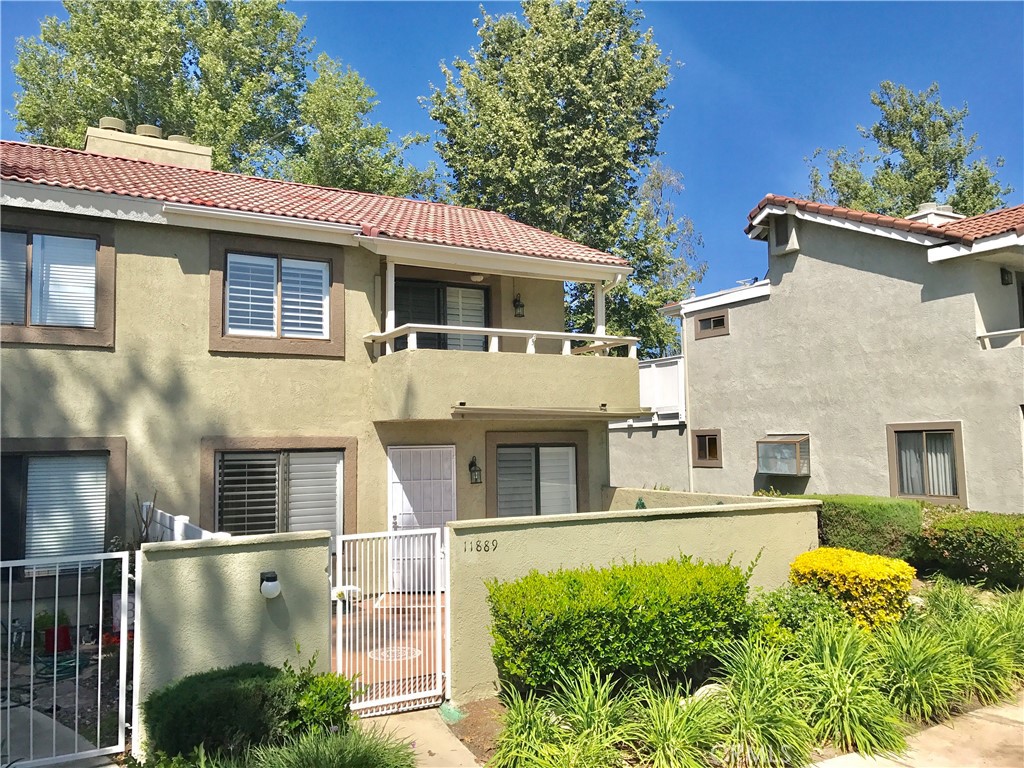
334, 528, 445, 716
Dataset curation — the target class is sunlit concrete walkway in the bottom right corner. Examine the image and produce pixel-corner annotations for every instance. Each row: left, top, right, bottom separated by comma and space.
817, 692, 1024, 768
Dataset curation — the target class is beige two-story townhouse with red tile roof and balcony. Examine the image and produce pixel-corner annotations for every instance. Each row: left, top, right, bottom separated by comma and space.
0, 121, 638, 560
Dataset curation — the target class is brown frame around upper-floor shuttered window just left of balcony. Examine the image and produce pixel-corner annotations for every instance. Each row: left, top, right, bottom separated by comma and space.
210, 233, 345, 358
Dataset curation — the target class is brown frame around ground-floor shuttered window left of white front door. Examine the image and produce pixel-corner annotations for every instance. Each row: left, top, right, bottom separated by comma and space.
199, 436, 358, 534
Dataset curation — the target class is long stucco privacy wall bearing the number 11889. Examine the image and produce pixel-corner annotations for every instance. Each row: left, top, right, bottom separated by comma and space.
447, 488, 818, 702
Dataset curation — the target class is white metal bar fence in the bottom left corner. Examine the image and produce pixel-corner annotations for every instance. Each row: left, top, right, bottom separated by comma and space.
0, 552, 134, 768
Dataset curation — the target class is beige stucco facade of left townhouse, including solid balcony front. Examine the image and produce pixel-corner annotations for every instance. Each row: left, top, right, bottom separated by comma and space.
0, 214, 638, 535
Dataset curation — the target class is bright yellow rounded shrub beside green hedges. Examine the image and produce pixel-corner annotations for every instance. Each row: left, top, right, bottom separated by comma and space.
790, 547, 915, 629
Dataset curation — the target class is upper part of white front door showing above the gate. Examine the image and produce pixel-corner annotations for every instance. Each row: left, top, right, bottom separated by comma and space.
388, 445, 456, 530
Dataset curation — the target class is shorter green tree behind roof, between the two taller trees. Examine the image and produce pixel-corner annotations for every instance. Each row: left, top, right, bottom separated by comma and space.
287, 54, 436, 197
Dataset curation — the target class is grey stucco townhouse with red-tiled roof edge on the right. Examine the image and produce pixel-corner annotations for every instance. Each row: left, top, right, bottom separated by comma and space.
610, 195, 1024, 513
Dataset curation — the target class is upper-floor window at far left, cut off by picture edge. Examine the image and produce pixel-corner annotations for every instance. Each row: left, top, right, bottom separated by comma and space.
0, 230, 96, 328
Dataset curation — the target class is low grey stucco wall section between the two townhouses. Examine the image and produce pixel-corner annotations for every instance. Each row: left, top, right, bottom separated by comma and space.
608, 424, 690, 490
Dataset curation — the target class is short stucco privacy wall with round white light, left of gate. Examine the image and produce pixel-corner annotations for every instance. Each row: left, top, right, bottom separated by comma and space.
135, 531, 331, 749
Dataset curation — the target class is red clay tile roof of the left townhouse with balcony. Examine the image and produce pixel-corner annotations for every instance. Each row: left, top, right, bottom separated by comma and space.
0, 141, 626, 266
